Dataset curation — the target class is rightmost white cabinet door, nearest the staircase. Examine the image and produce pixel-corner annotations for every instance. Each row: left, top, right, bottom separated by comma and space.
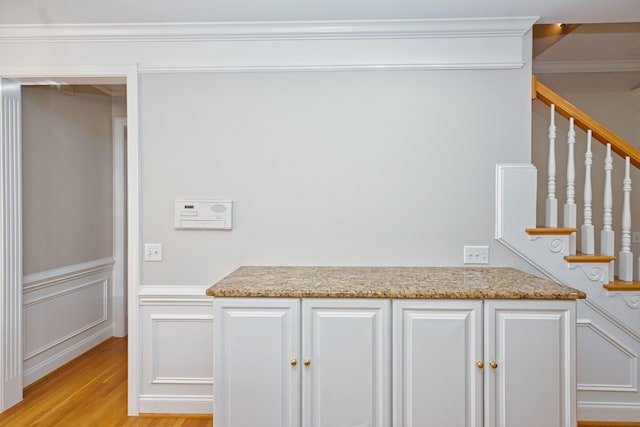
485, 300, 576, 427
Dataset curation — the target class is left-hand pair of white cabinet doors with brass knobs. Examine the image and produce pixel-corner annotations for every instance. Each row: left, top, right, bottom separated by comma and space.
214, 298, 391, 427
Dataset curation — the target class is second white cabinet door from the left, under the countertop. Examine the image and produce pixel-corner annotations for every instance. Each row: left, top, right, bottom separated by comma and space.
302, 299, 391, 427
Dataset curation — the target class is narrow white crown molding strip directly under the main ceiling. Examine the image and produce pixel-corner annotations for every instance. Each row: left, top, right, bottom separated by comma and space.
0, 17, 538, 43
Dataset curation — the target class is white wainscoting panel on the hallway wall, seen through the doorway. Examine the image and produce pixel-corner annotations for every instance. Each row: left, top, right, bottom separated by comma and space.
23, 258, 113, 386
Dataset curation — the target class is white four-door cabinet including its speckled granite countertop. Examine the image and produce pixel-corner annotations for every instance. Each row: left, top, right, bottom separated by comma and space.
207, 267, 585, 427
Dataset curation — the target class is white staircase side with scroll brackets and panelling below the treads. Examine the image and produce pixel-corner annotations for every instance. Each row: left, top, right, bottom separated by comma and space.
495, 164, 640, 421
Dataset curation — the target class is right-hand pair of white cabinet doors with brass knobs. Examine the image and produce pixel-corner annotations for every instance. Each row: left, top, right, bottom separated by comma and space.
392, 300, 576, 427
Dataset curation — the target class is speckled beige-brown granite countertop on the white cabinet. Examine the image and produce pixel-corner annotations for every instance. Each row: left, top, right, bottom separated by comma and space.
207, 266, 586, 300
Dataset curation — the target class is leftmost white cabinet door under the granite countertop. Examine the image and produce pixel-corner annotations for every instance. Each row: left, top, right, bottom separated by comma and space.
213, 298, 300, 427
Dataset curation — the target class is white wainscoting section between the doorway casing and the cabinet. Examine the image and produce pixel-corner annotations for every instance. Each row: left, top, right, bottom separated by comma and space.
140, 287, 213, 414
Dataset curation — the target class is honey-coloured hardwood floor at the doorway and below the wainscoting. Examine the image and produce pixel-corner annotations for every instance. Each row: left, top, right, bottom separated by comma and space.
0, 338, 213, 427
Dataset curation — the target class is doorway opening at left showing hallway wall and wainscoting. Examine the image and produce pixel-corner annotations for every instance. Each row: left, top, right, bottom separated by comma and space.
21, 79, 126, 386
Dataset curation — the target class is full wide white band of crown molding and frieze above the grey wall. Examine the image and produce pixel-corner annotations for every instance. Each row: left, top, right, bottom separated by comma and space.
0, 17, 537, 72
